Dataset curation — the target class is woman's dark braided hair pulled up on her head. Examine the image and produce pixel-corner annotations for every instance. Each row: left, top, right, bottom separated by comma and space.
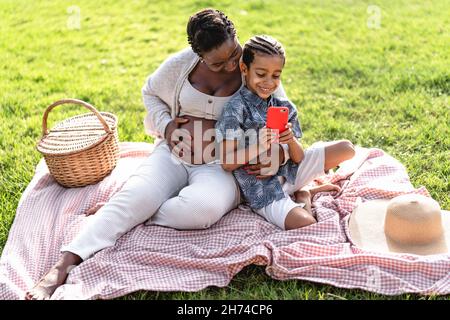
187, 9, 236, 56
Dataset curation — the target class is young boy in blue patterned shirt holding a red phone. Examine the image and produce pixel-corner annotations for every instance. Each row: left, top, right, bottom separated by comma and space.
216, 36, 353, 230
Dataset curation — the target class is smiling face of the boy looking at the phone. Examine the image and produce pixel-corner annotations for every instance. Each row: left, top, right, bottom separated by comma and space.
240, 53, 284, 99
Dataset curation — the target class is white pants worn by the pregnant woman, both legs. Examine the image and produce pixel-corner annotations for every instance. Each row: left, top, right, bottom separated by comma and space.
61, 143, 240, 260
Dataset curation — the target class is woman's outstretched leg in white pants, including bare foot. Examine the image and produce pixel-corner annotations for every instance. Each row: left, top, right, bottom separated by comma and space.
26, 145, 188, 299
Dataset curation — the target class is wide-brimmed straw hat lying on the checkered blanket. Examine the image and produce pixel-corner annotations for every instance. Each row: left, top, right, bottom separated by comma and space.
349, 194, 450, 255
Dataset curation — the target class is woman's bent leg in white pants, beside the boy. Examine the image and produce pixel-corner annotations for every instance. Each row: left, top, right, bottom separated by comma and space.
152, 164, 240, 230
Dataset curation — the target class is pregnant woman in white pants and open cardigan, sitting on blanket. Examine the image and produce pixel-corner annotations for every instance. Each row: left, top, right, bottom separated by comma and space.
26, 9, 287, 299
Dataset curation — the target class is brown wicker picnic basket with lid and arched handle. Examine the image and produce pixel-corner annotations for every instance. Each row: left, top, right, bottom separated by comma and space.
37, 99, 119, 188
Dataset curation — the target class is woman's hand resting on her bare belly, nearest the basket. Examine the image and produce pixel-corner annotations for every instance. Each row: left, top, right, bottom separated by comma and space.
164, 117, 192, 158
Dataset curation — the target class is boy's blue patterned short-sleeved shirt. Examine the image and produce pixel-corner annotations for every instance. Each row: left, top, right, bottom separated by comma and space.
216, 86, 302, 209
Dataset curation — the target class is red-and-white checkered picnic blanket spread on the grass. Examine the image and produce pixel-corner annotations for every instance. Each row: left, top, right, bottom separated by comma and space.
0, 142, 450, 299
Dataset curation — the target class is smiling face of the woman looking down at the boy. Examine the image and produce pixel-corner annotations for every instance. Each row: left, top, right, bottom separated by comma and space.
201, 37, 242, 73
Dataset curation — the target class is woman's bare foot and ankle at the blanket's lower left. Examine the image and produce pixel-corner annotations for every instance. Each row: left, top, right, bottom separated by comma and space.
25, 252, 82, 300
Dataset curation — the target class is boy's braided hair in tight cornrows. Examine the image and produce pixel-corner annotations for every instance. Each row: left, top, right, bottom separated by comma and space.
242, 35, 286, 68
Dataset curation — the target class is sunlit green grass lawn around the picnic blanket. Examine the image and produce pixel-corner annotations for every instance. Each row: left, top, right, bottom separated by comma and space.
0, 0, 450, 299
